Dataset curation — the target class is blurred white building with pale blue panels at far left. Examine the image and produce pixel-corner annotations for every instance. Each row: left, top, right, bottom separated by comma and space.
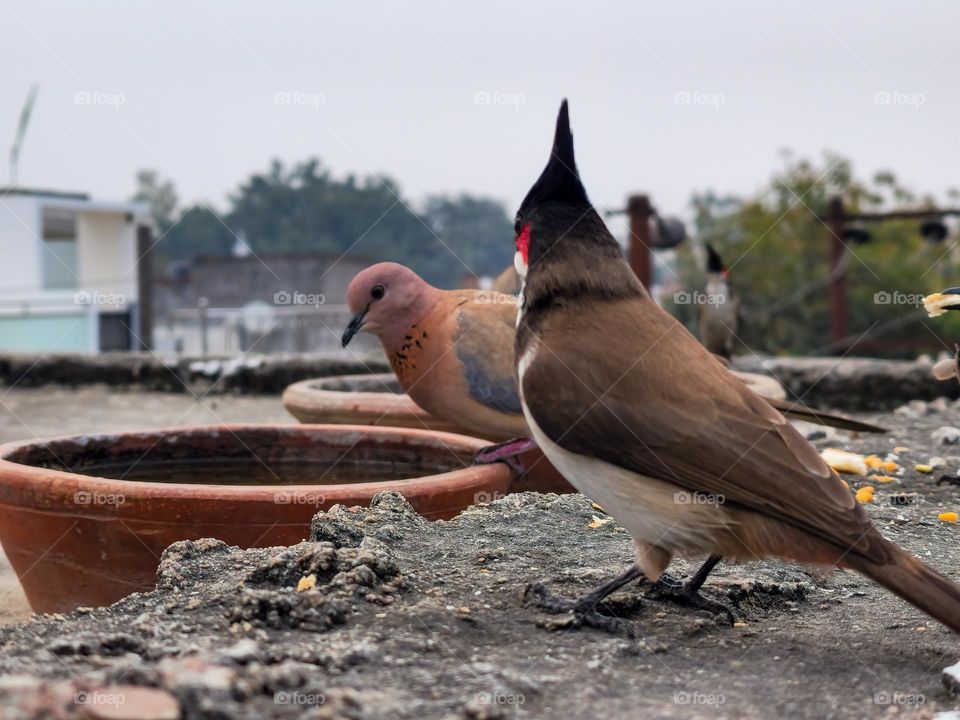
0, 188, 149, 352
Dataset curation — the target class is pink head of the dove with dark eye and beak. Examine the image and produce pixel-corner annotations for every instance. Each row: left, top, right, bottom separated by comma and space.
342, 263, 439, 347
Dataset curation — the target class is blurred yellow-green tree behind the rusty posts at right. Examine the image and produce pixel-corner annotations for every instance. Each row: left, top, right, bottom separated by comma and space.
673, 153, 960, 355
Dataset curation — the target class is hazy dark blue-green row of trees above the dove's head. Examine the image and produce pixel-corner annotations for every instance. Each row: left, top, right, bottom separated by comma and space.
140, 158, 512, 287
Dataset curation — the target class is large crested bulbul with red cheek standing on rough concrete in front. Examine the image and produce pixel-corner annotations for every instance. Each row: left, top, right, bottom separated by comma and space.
515, 101, 960, 631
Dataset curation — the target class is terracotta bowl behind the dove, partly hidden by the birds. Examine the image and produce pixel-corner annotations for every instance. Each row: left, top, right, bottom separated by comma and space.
282, 373, 576, 493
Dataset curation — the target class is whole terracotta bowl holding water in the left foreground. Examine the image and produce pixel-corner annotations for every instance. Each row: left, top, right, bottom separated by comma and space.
0, 425, 512, 612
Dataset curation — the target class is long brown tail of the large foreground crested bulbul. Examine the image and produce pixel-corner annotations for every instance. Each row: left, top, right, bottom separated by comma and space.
846, 541, 960, 633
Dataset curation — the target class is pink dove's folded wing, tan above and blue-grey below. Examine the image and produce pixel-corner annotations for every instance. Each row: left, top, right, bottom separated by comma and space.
455, 308, 523, 415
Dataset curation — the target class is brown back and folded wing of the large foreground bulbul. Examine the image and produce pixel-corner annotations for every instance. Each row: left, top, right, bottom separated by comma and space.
521, 299, 887, 562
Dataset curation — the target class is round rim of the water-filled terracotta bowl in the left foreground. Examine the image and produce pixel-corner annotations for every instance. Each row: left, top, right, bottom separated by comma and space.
0, 423, 513, 515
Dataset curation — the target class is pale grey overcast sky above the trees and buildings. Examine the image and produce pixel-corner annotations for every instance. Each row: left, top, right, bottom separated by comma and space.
0, 0, 960, 229
